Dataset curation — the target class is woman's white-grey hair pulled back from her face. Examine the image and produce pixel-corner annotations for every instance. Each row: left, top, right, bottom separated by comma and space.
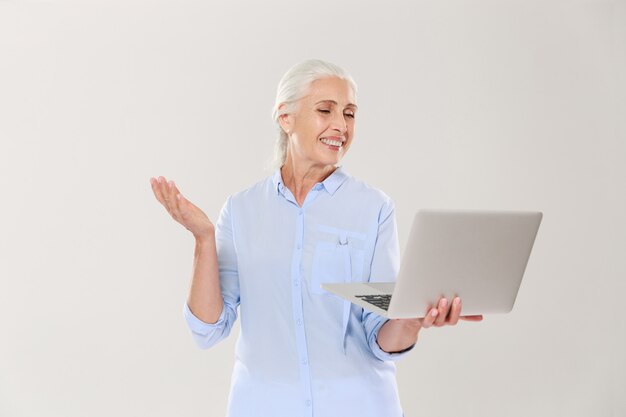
272, 59, 357, 168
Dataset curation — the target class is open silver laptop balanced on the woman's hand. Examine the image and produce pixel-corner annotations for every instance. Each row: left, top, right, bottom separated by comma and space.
322, 210, 542, 318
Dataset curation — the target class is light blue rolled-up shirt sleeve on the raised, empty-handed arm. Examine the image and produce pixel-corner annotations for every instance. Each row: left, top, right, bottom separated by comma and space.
183, 197, 240, 349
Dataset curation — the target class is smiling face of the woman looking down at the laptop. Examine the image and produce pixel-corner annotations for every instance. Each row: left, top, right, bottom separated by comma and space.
281, 77, 357, 166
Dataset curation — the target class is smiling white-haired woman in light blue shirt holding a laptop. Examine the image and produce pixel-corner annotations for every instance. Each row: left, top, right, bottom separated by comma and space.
150, 60, 480, 417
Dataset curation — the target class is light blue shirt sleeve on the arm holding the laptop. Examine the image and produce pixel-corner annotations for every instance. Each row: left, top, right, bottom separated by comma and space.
361, 199, 415, 361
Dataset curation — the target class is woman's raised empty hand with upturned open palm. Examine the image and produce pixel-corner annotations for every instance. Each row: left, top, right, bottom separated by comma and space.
150, 177, 215, 239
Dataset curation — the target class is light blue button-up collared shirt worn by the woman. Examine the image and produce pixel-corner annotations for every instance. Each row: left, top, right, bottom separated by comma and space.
184, 168, 412, 417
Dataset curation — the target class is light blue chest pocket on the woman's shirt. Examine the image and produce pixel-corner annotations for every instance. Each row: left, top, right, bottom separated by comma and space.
311, 226, 365, 295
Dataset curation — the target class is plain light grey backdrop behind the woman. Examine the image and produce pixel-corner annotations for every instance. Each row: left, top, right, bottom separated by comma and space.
0, 0, 626, 417
